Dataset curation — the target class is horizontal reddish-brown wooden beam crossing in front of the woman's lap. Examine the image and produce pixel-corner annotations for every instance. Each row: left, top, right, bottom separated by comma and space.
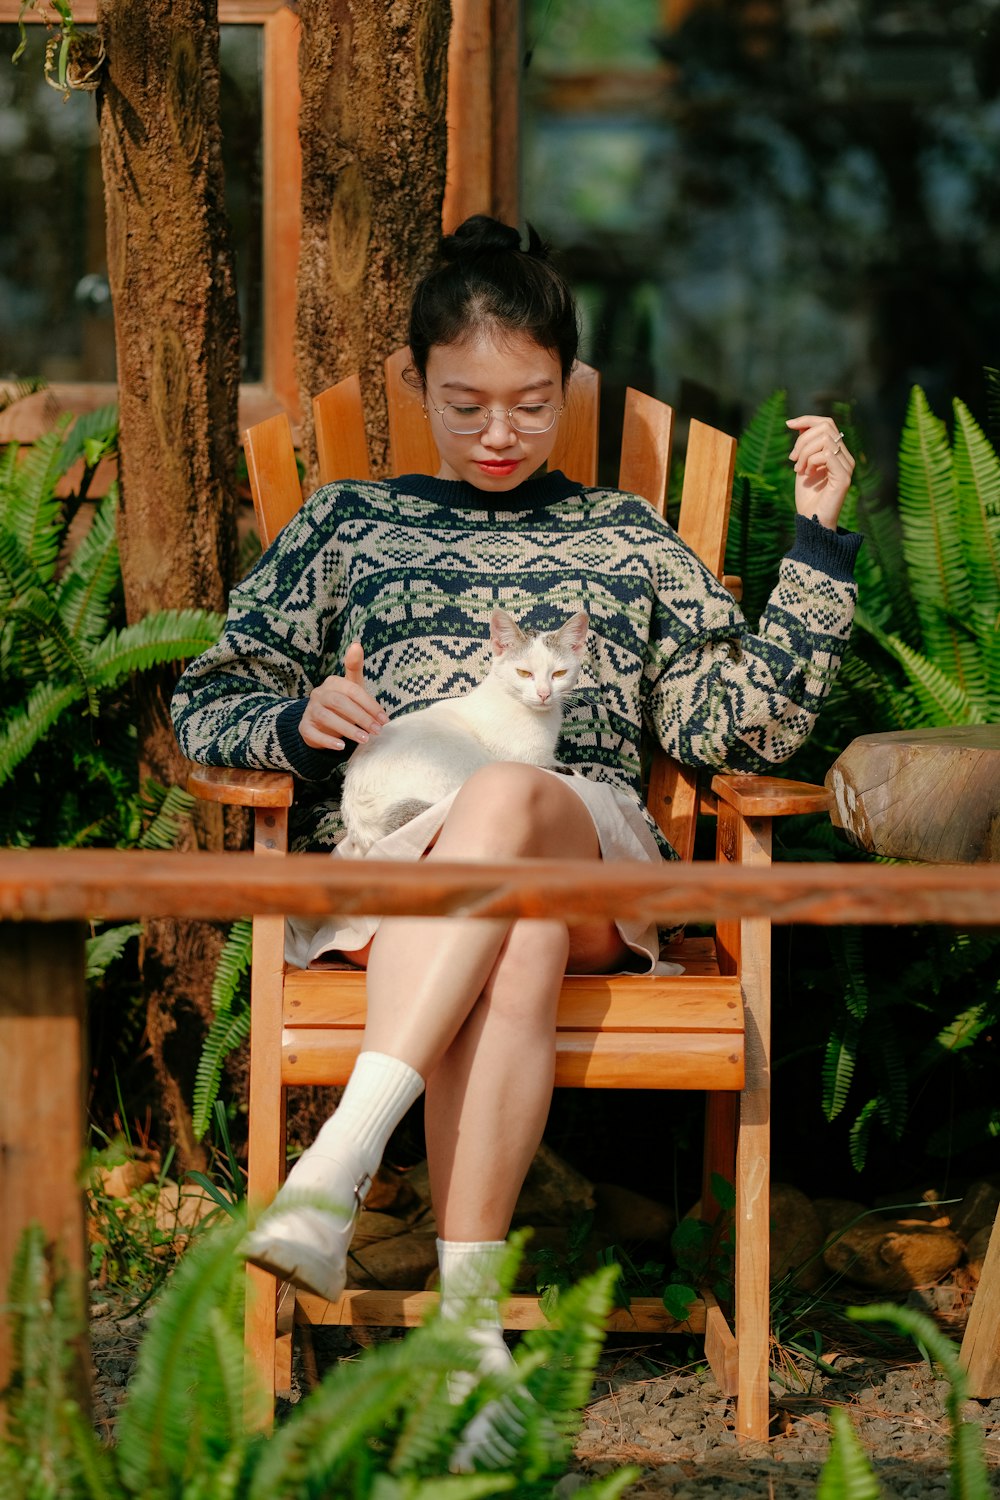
0, 849, 1000, 927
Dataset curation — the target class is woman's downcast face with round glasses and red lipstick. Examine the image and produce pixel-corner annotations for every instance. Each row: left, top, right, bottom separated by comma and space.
424, 333, 562, 494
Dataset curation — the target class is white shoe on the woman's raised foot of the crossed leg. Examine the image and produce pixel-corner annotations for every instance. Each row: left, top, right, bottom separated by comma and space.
240, 1148, 372, 1302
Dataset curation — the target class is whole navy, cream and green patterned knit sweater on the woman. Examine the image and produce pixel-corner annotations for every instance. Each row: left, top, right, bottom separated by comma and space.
172, 471, 861, 852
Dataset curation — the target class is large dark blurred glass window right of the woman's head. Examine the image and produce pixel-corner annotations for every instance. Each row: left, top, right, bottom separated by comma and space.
525, 0, 1000, 465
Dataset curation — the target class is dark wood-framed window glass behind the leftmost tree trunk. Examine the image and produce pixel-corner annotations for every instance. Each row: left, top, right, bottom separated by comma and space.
0, 26, 264, 383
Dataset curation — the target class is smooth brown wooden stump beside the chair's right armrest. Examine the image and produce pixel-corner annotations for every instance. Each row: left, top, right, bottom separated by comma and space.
826, 725, 1000, 864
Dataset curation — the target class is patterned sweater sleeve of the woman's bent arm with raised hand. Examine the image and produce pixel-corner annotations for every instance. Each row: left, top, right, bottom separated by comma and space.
643, 516, 862, 773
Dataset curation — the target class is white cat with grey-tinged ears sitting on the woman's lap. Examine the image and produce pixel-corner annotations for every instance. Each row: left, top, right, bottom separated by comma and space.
340, 609, 589, 854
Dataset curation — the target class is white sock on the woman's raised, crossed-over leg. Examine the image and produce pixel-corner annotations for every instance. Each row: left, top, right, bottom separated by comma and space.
309, 1052, 424, 1176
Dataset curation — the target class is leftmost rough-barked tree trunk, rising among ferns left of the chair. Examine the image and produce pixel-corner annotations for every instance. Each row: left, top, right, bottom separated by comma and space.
97, 0, 240, 1166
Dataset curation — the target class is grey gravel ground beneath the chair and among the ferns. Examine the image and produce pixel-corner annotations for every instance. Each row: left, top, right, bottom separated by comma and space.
91, 1307, 1000, 1500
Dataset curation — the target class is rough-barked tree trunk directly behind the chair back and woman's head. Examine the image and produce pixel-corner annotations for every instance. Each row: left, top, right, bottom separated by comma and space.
295, 0, 450, 488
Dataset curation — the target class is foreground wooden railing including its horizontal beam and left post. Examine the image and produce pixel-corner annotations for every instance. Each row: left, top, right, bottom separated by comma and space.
0, 849, 1000, 1410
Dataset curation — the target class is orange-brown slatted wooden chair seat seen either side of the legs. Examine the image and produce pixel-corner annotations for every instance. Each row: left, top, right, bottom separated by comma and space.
282, 938, 744, 1091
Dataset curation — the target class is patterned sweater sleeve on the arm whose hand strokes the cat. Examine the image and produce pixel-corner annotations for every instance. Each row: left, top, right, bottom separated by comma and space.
171, 506, 349, 782
